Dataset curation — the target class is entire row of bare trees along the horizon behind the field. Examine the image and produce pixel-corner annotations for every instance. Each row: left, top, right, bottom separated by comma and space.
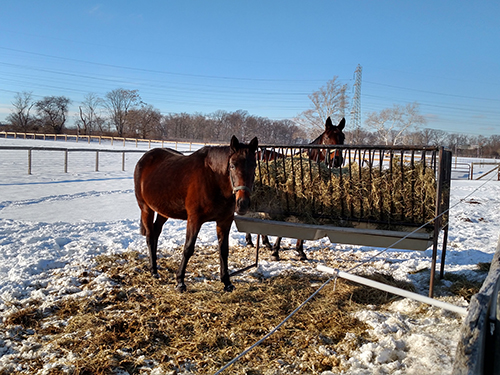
2, 81, 500, 158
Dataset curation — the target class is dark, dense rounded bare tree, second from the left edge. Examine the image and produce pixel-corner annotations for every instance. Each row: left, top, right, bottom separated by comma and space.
35, 96, 71, 134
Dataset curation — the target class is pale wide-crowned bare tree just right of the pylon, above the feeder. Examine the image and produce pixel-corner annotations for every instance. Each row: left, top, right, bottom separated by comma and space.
365, 102, 426, 145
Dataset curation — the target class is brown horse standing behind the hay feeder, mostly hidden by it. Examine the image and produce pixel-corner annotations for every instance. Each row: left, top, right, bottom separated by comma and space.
245, 117, 345, 260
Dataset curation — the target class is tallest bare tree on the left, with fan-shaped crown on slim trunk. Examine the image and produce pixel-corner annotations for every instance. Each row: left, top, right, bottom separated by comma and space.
104, 89, 141, 137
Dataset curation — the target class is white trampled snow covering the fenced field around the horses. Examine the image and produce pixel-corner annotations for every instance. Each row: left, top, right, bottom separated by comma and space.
0, 139, 500, 375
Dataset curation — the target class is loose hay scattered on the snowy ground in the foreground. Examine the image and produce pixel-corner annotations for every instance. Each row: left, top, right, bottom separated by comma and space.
4, 248, 428, 375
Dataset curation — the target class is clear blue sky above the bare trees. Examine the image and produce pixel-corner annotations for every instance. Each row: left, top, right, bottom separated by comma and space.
0, 0, 500, 136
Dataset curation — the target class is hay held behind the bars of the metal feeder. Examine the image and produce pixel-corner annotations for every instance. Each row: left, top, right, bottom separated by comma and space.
250, 155, 436, 226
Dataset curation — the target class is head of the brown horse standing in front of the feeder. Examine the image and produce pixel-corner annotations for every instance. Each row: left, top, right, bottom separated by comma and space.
228, 135, 258, 215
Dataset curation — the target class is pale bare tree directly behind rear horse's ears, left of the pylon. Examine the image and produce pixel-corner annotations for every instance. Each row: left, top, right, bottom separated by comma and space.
295, 76, 349, 137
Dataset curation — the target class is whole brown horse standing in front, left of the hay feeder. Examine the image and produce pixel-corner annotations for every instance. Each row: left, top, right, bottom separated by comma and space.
134, 136, 258, 292
